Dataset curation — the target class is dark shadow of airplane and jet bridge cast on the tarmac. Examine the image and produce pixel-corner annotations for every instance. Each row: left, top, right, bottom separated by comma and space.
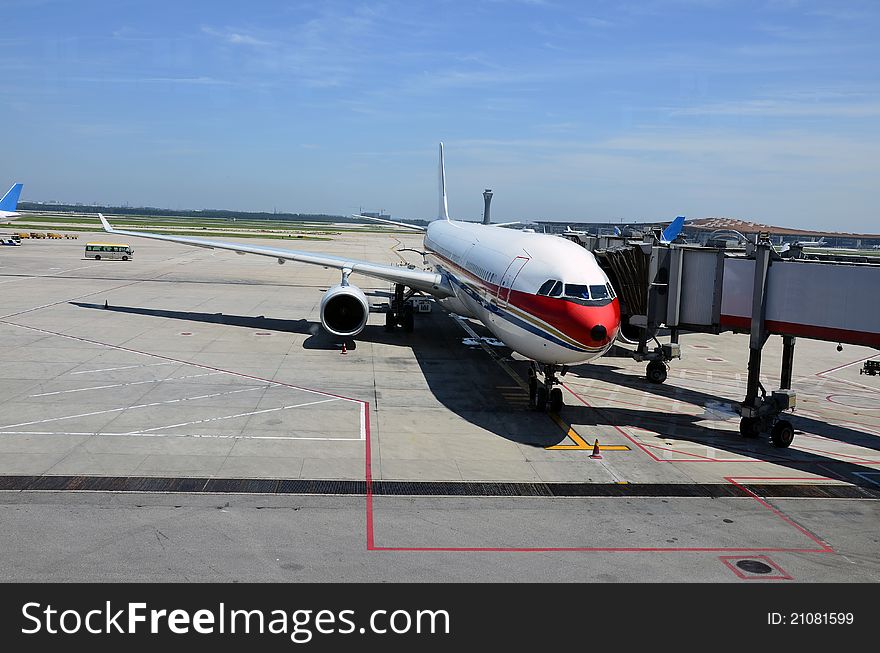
71, 302, 880, 478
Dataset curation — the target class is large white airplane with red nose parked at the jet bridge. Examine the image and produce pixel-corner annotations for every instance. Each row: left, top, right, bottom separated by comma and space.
98, 143, 620, 413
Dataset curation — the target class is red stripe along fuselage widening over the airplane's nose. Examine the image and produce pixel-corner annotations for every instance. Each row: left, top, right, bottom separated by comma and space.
429, 249, 620, 349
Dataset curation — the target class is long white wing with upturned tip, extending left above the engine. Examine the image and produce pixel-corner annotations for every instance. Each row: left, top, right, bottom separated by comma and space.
98, 213, 452, 297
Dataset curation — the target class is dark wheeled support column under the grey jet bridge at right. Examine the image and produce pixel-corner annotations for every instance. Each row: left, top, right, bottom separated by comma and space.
739, 234, 795, 447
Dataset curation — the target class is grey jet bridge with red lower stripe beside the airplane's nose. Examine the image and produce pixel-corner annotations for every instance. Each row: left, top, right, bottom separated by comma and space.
580, 236, 880, 447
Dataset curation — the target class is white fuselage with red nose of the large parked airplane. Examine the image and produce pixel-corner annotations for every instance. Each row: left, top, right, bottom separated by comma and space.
425, 220, 620, 365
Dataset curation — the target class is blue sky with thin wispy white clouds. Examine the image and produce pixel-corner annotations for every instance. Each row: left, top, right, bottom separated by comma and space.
0, 0, 880, 233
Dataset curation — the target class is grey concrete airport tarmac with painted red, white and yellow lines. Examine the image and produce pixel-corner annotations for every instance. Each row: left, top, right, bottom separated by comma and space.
0, 233, 880, 582
